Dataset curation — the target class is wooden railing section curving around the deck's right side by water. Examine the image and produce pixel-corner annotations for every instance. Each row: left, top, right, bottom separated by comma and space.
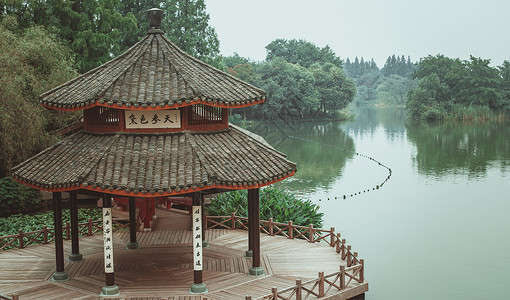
206, 214, 365, 300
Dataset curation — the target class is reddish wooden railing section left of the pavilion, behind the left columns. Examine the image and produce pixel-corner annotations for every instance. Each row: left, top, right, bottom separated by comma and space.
0, 219, 135, 250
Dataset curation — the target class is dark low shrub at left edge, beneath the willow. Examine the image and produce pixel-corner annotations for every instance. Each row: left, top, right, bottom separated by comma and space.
0, 177, 42, 216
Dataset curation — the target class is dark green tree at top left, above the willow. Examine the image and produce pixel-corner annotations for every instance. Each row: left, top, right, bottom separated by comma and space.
3, 0, 136, 72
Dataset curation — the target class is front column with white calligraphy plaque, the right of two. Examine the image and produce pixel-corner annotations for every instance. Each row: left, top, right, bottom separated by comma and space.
189, 192, 207, 294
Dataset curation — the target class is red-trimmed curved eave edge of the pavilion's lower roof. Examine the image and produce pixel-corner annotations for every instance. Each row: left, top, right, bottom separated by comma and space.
13, 171, 296, 198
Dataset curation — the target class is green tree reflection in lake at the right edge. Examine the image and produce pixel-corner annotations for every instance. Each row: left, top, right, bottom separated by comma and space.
406, 122, 510, 178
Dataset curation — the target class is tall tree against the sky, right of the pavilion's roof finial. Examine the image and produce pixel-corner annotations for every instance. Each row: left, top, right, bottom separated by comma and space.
162, 0, 221, 68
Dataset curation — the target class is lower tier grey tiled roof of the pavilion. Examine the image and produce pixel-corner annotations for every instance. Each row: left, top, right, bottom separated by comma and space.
13, 127, 296, 196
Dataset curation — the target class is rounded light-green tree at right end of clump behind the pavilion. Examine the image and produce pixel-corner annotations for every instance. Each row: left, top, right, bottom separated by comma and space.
310, 63, 356, 114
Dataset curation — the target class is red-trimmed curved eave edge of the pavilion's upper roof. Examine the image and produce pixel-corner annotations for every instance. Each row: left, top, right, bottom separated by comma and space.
41, 97, 266, 111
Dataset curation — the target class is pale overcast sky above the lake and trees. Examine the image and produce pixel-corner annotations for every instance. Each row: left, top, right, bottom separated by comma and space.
205, 0, 510, 68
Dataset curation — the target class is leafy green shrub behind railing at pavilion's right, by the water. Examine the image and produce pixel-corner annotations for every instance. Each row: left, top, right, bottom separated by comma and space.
205, 185, 323, 228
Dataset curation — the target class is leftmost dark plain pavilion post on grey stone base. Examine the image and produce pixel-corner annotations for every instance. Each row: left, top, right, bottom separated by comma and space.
52, 192, 69, 281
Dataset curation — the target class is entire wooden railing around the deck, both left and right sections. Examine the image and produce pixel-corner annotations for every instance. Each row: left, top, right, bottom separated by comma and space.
0, 214, 365, 300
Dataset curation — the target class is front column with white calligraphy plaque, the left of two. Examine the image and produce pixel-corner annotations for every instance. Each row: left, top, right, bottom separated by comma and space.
100, 194, 120, 296
